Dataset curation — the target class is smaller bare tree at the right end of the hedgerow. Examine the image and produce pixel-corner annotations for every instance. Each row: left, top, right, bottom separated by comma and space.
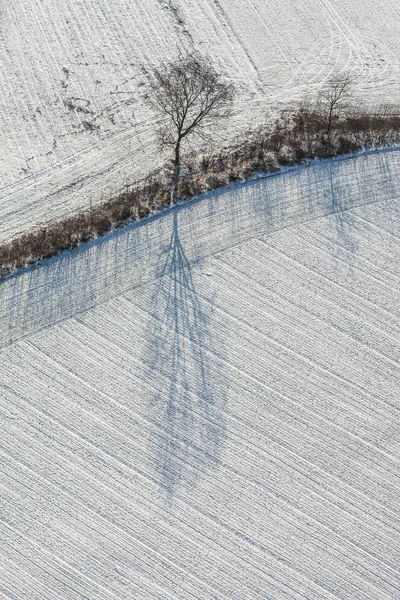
318, 73, 354, 144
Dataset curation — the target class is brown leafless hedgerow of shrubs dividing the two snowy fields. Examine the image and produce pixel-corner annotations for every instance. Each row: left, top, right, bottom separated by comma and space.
0, 108, 400, 277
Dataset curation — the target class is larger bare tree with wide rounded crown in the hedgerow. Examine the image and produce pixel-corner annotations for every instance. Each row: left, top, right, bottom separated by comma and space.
146, 56, 234, 202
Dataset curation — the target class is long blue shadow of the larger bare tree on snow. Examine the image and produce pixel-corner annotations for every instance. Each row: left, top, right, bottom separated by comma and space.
146, 210, 226, 497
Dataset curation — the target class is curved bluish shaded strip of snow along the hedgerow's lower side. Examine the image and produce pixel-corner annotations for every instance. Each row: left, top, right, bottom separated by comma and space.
0, 148, 400, 348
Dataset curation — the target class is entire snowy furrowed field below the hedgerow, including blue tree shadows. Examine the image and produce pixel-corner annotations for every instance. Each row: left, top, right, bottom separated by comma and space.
0, 150, 400, 600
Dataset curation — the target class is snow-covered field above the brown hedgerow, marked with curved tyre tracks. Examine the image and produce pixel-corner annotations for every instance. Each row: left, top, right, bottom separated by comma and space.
0, 0, 400, 240
